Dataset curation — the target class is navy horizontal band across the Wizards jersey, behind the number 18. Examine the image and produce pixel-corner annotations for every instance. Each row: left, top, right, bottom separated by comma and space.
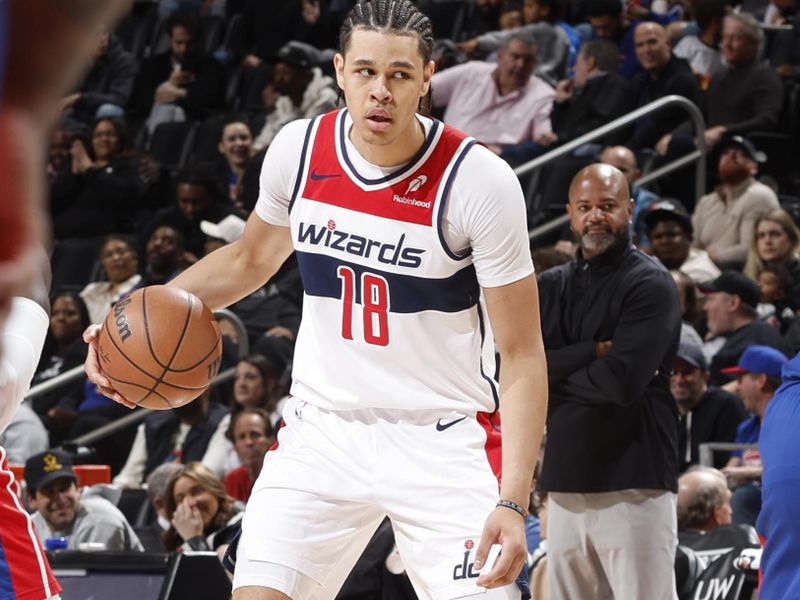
296, 250, 483, 314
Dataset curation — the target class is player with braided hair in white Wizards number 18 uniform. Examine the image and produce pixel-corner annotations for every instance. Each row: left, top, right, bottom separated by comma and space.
85, 0, 547, 600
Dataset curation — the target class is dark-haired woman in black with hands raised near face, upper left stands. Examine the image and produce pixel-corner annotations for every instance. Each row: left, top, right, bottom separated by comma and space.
50, 117, 146, 239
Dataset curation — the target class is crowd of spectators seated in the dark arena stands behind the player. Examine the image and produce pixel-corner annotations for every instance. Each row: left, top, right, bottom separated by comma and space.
9, 0, 800, 596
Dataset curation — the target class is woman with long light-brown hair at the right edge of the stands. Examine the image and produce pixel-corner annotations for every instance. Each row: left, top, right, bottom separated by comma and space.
744, 208, 800, 311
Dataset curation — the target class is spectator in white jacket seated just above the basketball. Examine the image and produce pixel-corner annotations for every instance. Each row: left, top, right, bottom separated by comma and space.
81, 233, 142, 323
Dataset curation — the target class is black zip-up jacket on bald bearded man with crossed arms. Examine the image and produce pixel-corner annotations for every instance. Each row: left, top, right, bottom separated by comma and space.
539, 241, 681, 493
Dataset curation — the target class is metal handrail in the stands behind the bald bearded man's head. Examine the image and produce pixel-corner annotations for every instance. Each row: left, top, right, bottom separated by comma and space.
514, 94, 708, 240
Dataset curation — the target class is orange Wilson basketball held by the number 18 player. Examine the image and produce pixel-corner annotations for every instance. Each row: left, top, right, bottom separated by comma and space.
97, 285, 222, 410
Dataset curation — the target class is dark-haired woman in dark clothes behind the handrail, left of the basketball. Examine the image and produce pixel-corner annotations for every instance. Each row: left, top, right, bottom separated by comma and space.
31, 292, 92, 437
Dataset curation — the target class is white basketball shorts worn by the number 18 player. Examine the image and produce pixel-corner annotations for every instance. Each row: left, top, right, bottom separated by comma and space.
233, 398, 520, 600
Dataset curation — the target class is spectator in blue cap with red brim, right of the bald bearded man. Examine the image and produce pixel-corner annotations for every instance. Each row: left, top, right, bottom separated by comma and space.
722, 346, 788, 526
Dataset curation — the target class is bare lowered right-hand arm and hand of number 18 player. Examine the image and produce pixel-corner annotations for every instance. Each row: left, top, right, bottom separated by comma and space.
475, 275, 547, 587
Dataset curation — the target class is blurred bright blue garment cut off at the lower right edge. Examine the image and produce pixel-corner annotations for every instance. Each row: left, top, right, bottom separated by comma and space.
756, 344, 800, 599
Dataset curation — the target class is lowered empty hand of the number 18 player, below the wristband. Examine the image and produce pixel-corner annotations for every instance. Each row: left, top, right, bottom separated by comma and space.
475, 507, 528, 588
